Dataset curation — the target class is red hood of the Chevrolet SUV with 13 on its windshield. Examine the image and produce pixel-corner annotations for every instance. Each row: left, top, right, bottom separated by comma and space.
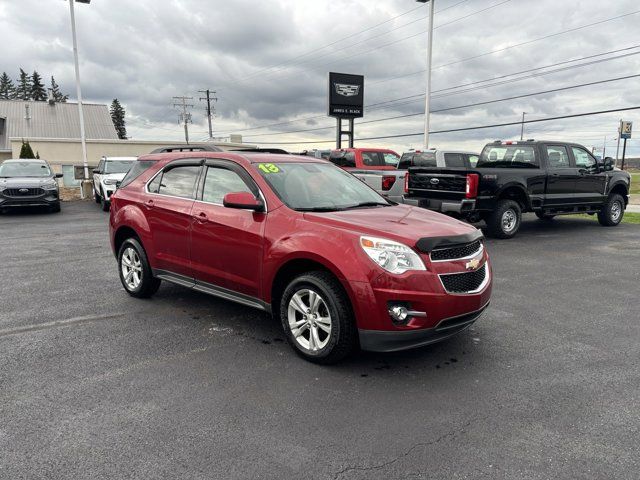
304, 205, 476, 246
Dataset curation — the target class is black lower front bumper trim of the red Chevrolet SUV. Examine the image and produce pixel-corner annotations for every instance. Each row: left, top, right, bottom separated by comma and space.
358, 303, 489, 352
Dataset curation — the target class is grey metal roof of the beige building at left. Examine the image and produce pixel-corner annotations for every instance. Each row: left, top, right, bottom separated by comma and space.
0, 100, 118, 150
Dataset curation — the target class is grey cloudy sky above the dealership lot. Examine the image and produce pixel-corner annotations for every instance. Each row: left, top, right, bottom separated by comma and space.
0, 0, 640, 155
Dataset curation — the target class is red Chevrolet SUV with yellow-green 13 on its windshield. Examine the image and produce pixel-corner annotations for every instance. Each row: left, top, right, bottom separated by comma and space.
109, 152, 491, 363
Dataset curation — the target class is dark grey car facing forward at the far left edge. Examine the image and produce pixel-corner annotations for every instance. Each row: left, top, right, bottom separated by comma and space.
0, 158, 62, 212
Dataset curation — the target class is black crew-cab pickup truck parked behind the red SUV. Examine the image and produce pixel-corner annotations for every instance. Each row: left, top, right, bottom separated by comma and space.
403, 140, 631, 238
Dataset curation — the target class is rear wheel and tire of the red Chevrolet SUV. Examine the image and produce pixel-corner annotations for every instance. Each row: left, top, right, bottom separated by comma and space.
118, 238, 160, 298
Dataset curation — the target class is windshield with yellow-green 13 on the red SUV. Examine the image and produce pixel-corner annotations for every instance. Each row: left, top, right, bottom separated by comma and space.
254, 163, 391, 211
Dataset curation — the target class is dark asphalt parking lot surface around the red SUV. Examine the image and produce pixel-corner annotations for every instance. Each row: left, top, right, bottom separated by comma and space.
0, 202, 640, 480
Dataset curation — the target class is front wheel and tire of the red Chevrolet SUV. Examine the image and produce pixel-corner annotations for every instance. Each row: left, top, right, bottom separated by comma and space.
280, 271, 357, 365
